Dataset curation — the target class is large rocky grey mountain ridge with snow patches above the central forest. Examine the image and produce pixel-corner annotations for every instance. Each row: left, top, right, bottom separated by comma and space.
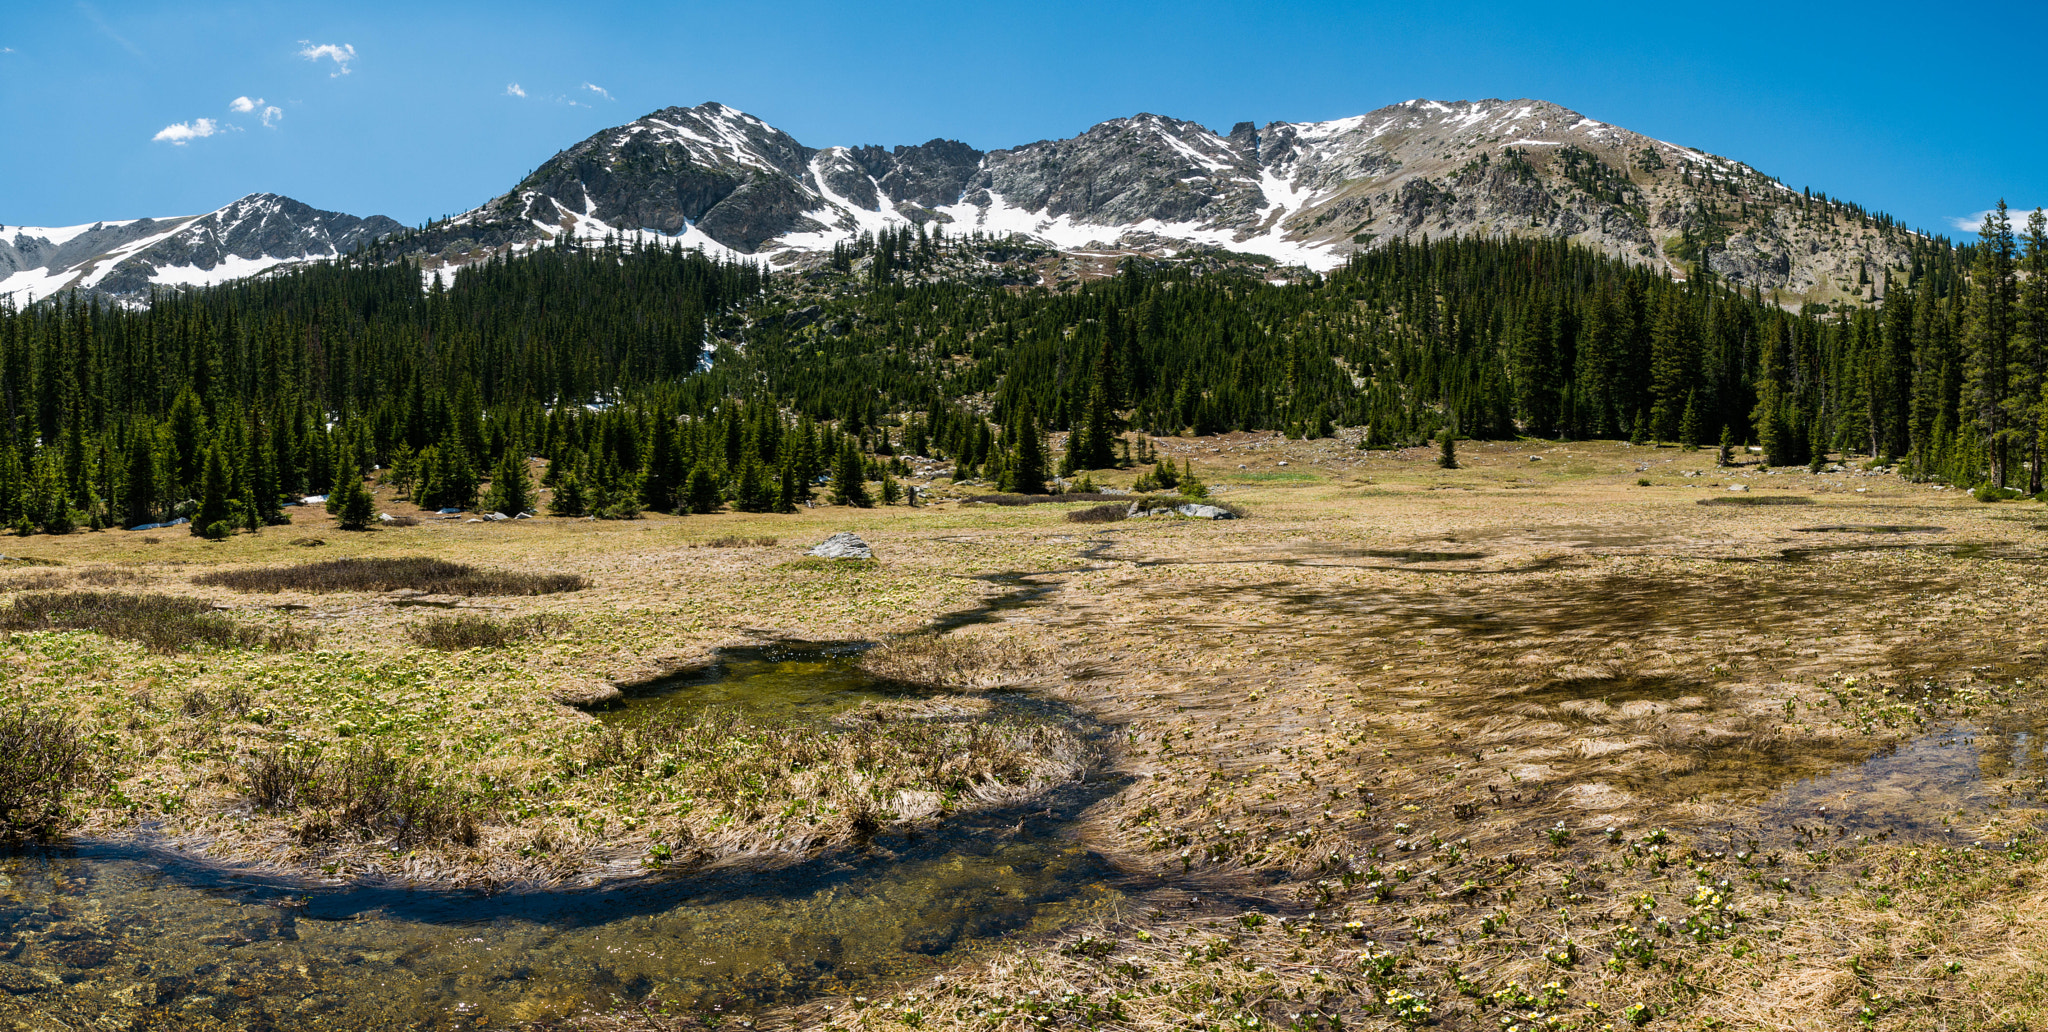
403, 100, 1907, 299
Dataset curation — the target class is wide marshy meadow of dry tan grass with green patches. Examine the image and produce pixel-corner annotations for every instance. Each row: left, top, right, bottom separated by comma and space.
0, 434, 2048, 1032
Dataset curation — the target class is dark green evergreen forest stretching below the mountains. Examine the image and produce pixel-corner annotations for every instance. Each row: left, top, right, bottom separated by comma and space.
0, 207, 2048, 536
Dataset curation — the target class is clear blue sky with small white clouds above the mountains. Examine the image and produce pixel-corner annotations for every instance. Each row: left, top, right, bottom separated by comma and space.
0, 0, 2048, 231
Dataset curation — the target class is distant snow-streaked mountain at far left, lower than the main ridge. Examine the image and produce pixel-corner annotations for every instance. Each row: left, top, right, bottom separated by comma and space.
0, 192, 401, 305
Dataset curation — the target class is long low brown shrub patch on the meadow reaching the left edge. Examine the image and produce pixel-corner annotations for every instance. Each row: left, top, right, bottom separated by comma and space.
0, 592, 313, 653
